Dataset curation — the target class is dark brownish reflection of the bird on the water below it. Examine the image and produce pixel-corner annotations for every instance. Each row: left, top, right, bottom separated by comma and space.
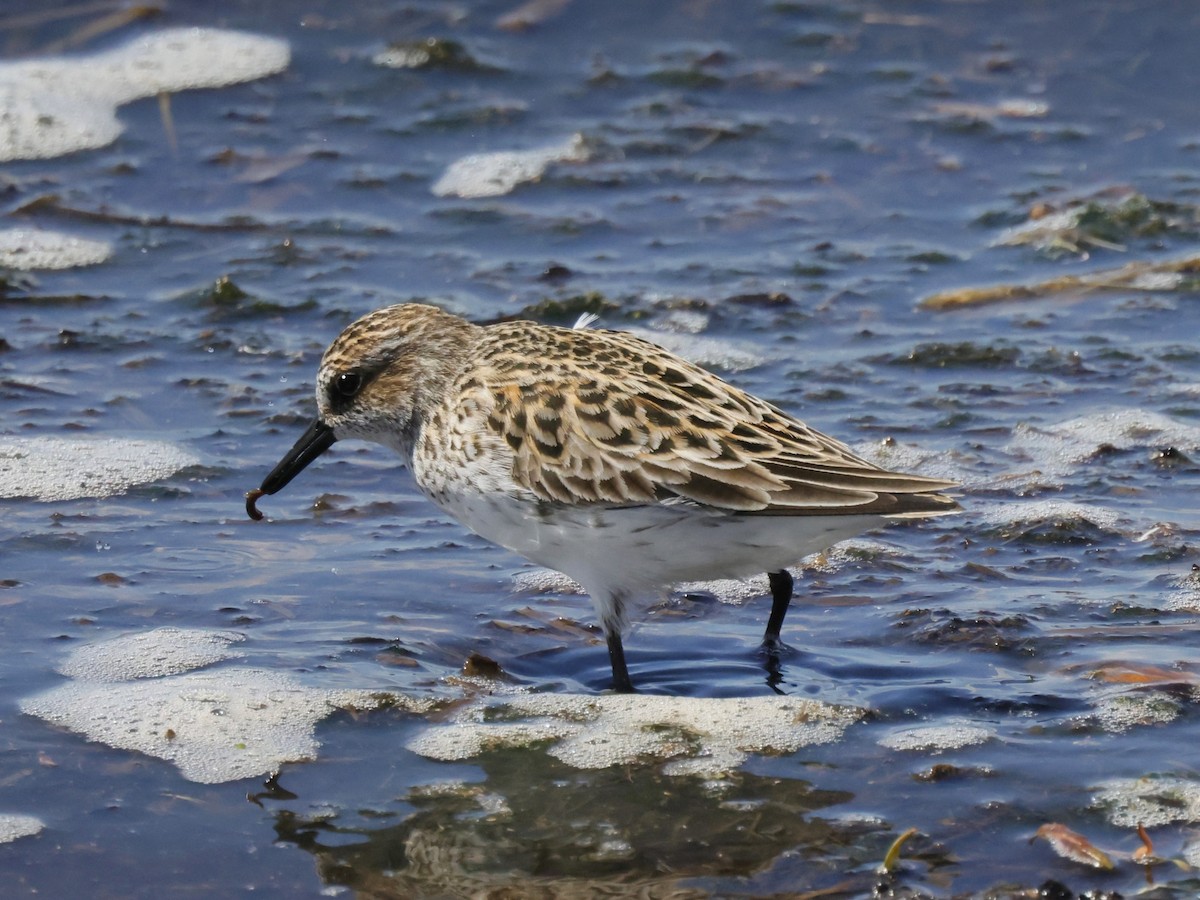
275, 751, 864, 898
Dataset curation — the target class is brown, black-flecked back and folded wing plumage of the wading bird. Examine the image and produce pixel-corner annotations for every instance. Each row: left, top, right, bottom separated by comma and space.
480, 323, 956, 515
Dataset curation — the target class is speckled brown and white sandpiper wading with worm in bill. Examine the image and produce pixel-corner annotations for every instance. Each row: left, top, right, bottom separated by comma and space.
245, 302, 960, 692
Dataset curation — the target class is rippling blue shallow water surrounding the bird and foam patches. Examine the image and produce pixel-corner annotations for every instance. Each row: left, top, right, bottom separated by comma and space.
0, 2, 1200, 896
